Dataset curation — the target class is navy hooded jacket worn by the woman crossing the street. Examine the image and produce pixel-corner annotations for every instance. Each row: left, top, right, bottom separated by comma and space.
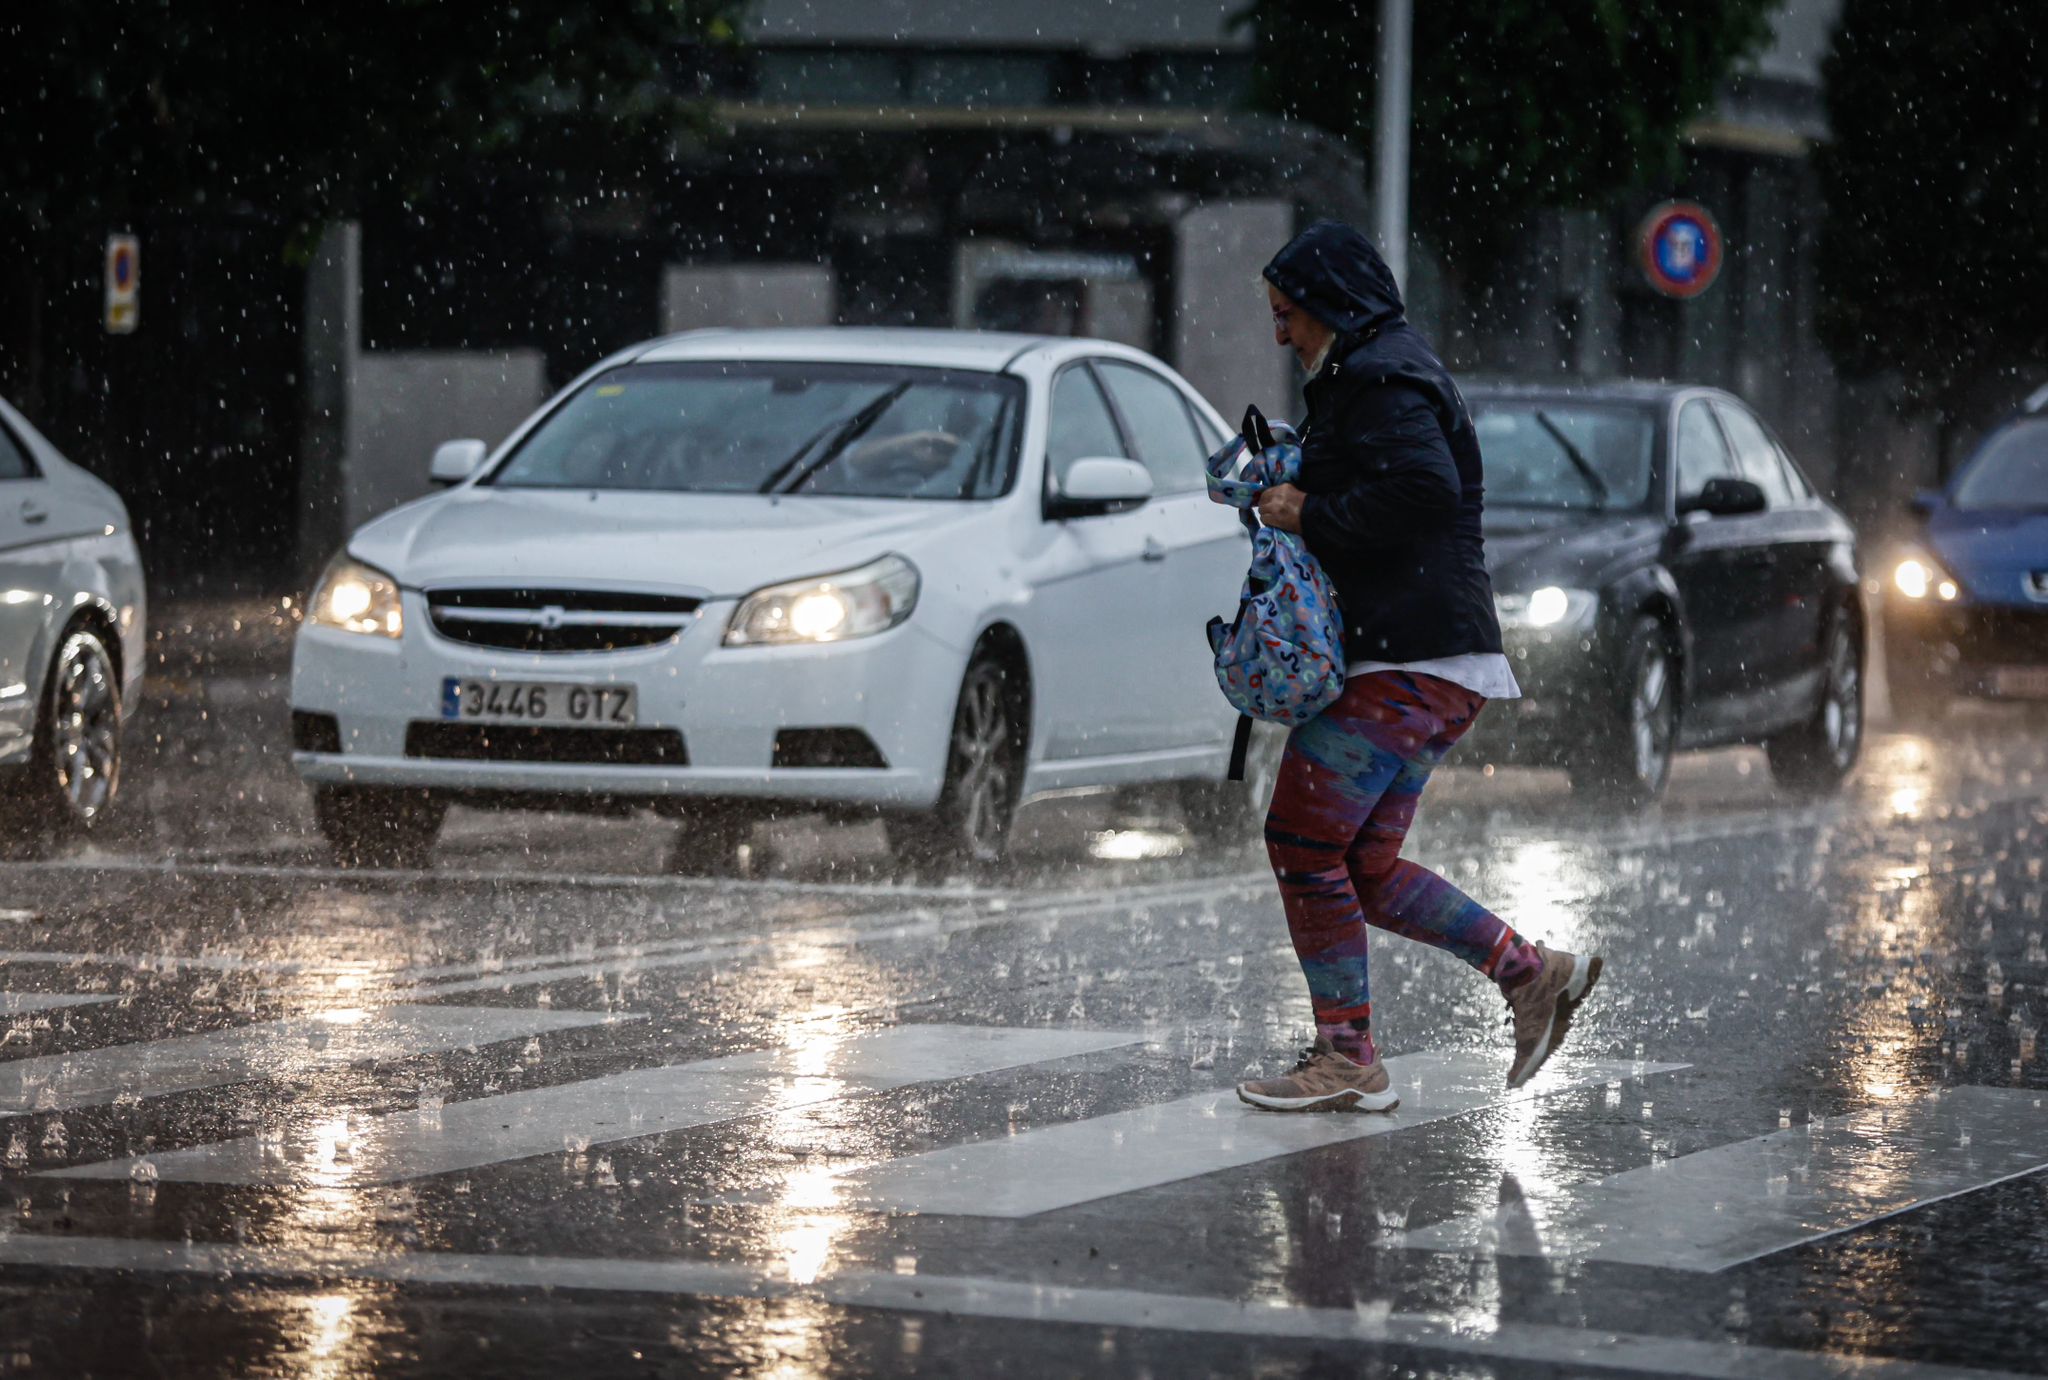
1266, 221, 1501, 661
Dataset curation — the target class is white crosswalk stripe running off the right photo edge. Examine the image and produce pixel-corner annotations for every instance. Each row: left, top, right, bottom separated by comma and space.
1401, 1087, 2048, 1271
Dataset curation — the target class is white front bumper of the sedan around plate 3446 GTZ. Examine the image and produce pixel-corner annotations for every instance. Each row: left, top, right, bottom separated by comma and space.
291, 590, 965, 809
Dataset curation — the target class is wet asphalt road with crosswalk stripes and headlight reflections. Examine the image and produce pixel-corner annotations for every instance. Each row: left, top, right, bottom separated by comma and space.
0, 606, 2048, 1378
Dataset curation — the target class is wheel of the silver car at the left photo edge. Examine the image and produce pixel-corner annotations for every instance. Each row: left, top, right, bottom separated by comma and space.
0, 627, 121, 856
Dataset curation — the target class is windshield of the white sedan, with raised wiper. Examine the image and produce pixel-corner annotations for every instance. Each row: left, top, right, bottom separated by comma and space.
485, 360, 1024, 500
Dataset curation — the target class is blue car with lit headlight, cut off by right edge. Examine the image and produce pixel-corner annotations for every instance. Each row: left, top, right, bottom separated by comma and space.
1884, 389, 2048, 715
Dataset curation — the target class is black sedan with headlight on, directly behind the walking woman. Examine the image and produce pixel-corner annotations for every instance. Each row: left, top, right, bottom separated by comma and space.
1460, 383, 1866, 803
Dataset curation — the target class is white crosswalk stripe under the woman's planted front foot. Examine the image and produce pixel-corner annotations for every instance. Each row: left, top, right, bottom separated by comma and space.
806, 1052, 1688, 1216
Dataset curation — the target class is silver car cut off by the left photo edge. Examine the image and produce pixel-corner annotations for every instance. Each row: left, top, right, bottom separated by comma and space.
0, 401, 147, 846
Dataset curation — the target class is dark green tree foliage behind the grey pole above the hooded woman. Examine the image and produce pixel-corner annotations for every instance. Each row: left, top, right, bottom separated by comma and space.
1243, 0, 1782, 262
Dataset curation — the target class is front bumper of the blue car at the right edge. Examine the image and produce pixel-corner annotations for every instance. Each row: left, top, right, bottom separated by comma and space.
1884, 596, 2048, 700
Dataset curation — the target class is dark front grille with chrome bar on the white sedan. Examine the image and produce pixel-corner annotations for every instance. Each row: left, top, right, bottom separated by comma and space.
426, 588, 702, 651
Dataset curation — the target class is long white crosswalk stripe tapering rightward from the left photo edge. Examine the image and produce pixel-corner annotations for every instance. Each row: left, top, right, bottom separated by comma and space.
0, 1005, 639, 1116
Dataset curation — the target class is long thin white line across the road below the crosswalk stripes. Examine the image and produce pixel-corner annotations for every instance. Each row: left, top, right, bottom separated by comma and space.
0, 1233, 2015, 1380
